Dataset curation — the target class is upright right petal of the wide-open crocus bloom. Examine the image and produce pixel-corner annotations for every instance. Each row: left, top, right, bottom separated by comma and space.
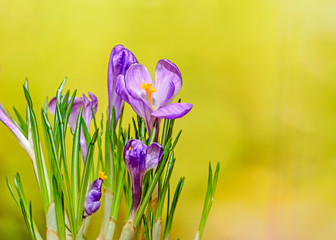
155, 59, 182, 106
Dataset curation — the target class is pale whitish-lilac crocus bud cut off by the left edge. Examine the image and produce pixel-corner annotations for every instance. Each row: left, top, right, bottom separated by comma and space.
0, 104, 38, 175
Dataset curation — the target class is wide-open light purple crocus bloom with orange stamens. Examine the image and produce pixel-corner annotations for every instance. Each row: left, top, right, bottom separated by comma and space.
116, 59, 192, 134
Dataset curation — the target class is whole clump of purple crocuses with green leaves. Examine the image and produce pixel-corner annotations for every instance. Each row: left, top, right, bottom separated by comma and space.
0, 45, 219, 240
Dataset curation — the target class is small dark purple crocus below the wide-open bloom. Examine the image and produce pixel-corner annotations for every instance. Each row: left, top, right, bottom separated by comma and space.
123, 139, 163, 221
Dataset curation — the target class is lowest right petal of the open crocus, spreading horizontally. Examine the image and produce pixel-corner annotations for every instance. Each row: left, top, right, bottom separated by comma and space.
152, 103, 193, 119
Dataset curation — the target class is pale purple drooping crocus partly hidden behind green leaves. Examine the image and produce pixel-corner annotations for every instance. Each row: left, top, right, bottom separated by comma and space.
49, 92, 98, 162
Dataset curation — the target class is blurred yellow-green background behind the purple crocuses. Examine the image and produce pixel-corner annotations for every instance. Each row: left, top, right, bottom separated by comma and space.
0, 0, 336, 240
